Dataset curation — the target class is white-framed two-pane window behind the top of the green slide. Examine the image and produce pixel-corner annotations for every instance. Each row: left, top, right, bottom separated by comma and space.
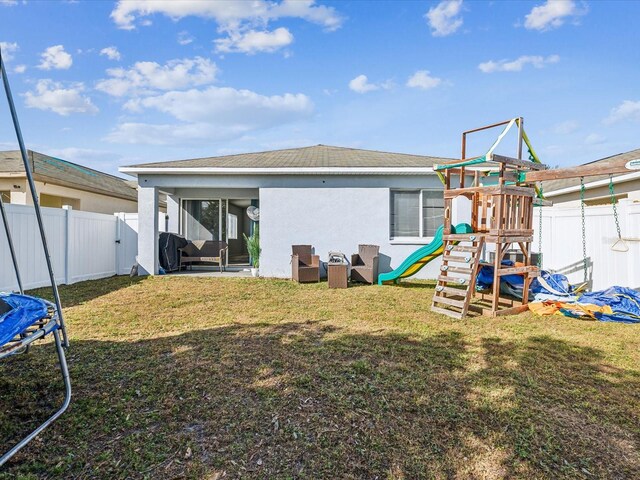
390, 190, 444, 238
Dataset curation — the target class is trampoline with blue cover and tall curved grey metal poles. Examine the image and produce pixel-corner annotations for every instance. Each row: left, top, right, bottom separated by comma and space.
0, 45, 71, 466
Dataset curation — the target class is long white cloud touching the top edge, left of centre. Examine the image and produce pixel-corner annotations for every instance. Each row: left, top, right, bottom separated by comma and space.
111, 0, 344, 30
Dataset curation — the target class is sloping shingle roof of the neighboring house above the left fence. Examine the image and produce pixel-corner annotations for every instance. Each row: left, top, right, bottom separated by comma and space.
0, 150, 138, 201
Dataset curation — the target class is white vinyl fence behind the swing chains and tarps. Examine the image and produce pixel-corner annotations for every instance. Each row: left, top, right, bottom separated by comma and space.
533, 200, 640, 290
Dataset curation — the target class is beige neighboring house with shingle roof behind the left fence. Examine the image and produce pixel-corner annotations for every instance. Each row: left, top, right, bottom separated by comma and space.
0, 150, 138, 214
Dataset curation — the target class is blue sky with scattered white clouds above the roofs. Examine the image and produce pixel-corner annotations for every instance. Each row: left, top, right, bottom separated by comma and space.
0, 0, 640, 173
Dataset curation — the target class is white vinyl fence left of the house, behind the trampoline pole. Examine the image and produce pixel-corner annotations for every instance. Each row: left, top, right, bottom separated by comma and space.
0, 204, 165, 291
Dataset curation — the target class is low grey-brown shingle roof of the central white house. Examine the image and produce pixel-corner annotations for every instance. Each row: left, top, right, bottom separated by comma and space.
120, 145, 451, 173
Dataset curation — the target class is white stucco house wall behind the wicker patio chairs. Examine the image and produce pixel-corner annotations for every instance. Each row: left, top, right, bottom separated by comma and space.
260, 188, 470, 279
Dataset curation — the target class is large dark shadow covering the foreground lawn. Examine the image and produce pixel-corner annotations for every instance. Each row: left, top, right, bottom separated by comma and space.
0, 322, 640, 479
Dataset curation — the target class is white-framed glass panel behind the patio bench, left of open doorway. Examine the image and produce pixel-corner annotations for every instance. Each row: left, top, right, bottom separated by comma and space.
182, 199, 227, 241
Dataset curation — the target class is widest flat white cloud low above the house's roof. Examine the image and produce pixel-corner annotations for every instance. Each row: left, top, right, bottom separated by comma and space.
107, 86, 313, 145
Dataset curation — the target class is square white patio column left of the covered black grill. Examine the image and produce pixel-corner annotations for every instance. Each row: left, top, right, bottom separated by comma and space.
138, 185, 159, 275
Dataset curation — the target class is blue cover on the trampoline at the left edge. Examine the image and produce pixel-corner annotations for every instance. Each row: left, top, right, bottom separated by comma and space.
0, 293, 49, 346
